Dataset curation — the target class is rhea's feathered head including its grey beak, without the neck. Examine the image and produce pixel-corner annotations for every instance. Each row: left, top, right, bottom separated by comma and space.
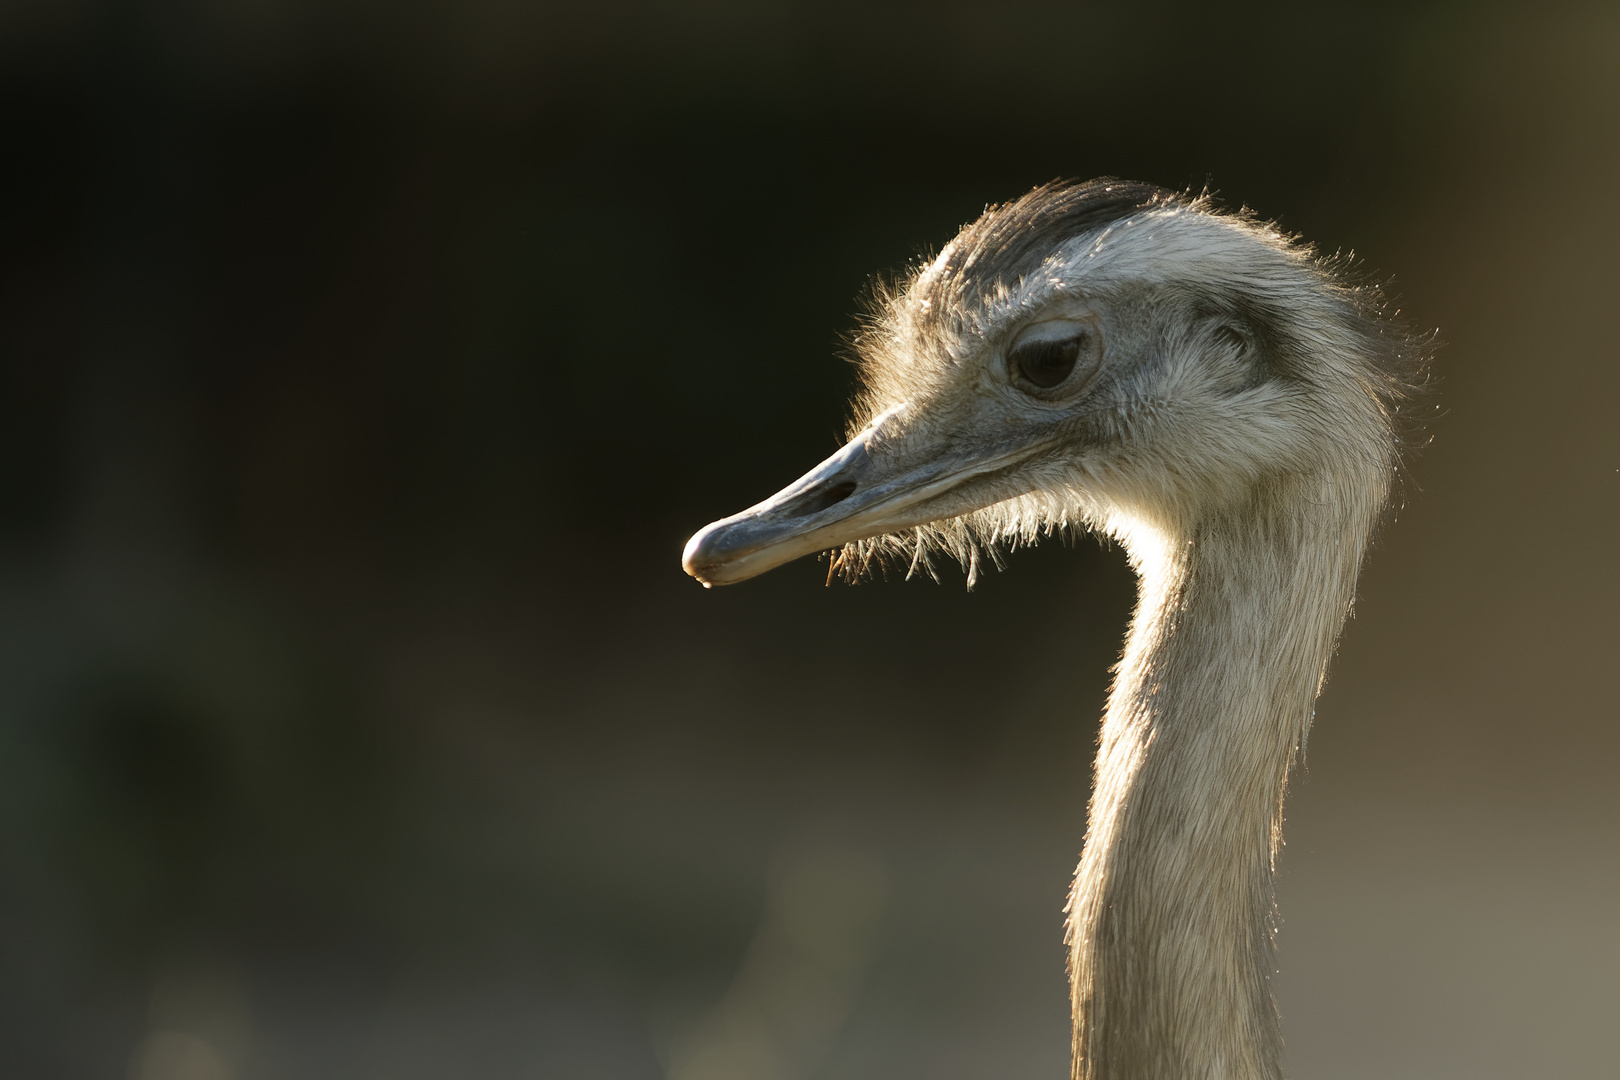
682, 180, 1421, 585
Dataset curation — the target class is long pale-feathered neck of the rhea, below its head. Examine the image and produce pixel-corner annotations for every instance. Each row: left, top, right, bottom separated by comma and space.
1069, 487, 1372, 1080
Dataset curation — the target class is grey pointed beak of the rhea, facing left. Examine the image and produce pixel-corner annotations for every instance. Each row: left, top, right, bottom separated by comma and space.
680, 405, 1030, 588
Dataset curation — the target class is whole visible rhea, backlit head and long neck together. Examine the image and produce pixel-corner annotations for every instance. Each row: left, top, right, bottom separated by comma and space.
684, 180, 1426, 1080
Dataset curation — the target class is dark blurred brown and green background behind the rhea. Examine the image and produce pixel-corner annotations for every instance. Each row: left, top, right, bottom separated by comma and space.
0, 0, 1620, 1080
